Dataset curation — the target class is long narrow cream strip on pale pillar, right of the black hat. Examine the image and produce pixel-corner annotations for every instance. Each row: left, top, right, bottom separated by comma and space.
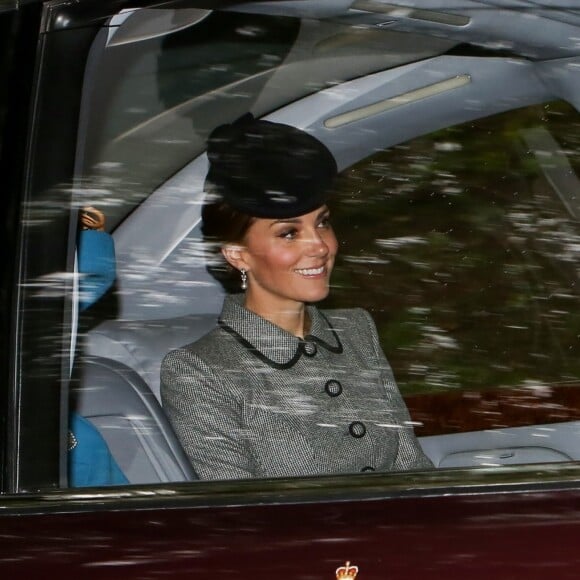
324, 74, 471, 129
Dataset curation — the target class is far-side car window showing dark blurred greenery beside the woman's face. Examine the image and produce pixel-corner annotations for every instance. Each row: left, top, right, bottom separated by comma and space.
330, 102, 580, 444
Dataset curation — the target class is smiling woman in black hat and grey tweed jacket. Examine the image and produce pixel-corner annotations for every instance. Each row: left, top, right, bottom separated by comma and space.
161, 115, 432, 479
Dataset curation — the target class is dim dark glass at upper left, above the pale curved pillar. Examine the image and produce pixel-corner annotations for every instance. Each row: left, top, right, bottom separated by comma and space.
78, 10, 453, 230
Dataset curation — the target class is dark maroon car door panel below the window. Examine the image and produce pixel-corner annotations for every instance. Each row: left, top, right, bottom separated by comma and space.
0, 472, 580, 580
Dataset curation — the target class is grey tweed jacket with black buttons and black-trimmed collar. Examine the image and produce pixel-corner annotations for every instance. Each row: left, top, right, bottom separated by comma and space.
161, 295, 433, 479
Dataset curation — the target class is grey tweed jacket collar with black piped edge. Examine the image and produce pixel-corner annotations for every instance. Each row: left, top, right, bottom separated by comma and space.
218, 294, 342, 369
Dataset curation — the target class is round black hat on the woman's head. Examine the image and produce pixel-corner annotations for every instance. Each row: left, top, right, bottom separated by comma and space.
206, 113, 337, 219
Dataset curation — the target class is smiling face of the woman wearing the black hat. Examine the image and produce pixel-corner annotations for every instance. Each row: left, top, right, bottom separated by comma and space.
225, 206, 338, 311
